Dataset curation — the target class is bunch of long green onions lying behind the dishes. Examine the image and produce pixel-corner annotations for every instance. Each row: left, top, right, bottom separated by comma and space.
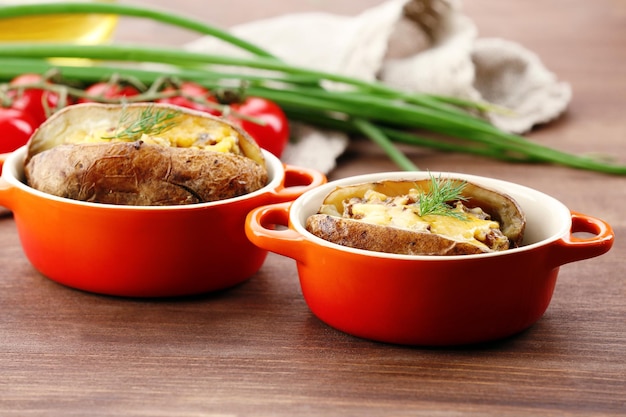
0, 2, 626, 175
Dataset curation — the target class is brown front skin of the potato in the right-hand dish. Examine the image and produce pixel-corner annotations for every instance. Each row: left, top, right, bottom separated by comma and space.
306, 214, 485, 256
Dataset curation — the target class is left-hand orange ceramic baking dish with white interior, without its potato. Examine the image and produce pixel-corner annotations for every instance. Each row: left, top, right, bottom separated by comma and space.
0, 147, 326, 297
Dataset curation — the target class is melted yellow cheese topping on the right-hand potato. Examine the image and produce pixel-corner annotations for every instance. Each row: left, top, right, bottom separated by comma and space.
321, 190, 500, 247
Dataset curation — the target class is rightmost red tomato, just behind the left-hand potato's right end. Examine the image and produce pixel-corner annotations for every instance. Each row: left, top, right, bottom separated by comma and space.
229, 97, 289, 158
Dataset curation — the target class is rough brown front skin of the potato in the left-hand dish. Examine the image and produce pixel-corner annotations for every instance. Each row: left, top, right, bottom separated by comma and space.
24, 141, 267, 206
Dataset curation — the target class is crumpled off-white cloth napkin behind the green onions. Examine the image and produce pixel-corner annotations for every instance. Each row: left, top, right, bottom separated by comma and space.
185, 0, 572, 173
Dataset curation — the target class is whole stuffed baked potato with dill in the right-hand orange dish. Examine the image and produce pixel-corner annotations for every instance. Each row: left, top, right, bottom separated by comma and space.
306, 177, 526, 255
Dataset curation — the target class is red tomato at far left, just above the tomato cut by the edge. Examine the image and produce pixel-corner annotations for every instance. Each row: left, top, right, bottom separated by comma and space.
9, 73, 59, 126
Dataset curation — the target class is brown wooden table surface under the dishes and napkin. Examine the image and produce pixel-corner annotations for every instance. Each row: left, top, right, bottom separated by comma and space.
0, 0, 626, 417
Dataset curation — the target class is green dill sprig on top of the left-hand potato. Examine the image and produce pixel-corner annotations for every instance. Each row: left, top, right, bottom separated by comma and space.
102, 106, 181, 141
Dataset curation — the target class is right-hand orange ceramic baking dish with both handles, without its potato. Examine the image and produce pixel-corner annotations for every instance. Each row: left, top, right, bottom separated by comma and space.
246, 172, 614, 346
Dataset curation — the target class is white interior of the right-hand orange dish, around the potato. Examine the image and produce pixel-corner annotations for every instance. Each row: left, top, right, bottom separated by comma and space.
290, 172, 572, 259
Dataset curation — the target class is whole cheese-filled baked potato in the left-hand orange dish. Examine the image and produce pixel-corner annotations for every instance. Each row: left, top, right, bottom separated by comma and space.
24, 103, 268, 206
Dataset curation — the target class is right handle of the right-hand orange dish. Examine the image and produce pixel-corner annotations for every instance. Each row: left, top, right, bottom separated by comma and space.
550, 211, 615, 266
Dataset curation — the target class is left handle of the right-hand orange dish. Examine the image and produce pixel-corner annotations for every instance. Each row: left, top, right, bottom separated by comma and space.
245, 202, 307, 260
